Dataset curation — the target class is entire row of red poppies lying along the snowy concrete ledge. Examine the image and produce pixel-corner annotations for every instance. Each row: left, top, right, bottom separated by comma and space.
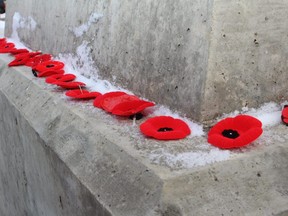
0, 38, 288, 149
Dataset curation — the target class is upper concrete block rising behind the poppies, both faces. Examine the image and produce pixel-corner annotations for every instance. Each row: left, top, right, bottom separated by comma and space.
6, 0, 288, 121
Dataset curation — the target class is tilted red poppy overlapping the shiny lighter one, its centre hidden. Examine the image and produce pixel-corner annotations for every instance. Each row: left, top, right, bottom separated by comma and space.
111, 100, 155, 116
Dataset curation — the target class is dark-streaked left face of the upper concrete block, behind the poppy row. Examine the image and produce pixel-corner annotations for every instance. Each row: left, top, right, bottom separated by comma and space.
6, 0, 211, 118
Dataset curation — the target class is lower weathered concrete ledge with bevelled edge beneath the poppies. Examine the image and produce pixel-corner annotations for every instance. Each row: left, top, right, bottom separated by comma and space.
0, 55, 288, 216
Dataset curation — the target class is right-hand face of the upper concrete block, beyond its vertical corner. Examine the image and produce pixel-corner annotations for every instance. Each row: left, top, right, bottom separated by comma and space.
201, 0, 288, 119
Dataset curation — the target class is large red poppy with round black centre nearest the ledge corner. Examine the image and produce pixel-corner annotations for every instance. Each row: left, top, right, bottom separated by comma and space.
208, 115, 263, 149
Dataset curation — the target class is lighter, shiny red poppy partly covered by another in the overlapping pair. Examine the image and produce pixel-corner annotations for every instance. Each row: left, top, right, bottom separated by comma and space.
101, 94, 140, 112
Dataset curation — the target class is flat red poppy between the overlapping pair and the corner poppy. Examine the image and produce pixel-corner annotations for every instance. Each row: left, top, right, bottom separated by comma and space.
140, 116, 191, 140
